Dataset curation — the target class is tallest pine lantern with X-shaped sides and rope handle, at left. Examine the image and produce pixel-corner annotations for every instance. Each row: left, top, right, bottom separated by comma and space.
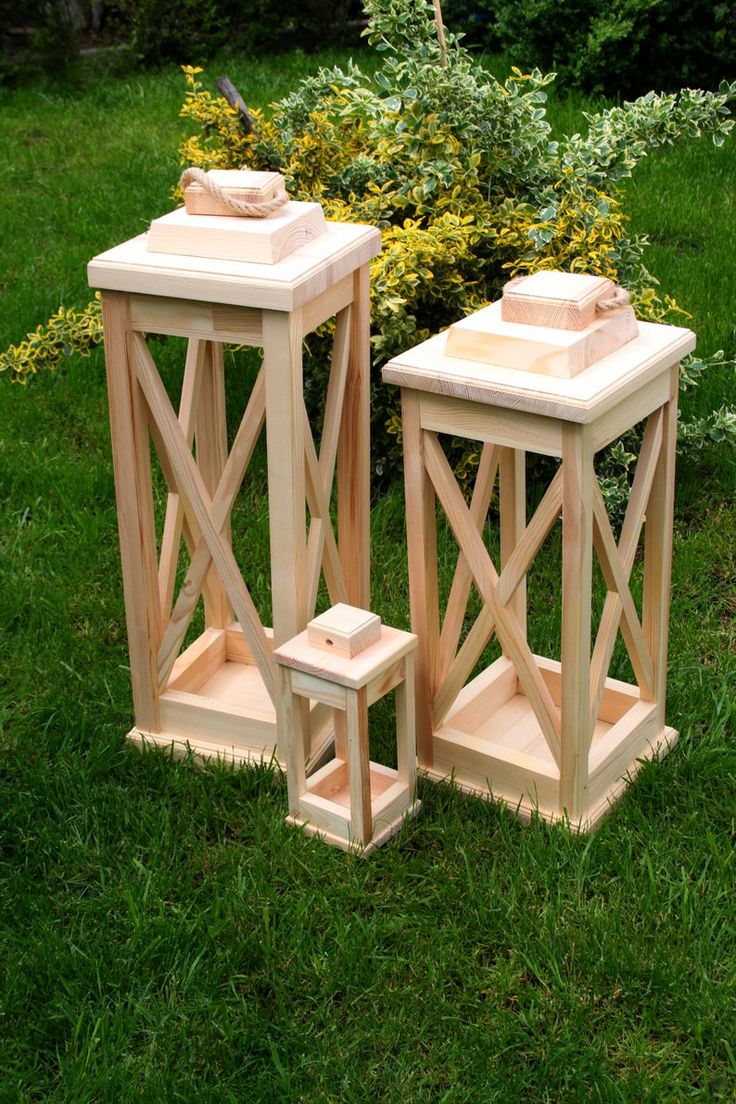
88, 173, 381, 764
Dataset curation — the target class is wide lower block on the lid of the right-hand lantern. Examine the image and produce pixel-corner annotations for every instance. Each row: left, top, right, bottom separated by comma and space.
446, 302, 638, 380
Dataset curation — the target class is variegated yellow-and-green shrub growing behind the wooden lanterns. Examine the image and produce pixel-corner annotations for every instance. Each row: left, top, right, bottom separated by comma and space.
0, 0, 736, 492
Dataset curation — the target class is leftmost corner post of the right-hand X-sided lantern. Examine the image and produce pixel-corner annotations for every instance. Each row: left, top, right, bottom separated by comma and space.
402, 391, 439, 766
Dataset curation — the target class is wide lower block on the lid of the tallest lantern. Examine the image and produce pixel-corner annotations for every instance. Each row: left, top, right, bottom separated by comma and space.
148, 202, 326, 265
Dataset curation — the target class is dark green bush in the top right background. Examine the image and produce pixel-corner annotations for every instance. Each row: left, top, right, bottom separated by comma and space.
446, 0, 736, 96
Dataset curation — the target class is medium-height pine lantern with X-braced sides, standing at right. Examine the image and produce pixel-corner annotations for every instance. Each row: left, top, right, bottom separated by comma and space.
384, 273, 695, 829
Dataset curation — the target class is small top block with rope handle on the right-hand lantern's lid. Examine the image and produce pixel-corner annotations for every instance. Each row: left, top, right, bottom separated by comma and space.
501, 272, 616, 330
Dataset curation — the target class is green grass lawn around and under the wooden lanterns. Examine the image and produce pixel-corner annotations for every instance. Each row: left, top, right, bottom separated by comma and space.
0, 49, 736, 1104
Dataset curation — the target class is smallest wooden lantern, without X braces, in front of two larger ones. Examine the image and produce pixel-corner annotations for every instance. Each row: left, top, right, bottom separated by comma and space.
274, 603, 419, 852
